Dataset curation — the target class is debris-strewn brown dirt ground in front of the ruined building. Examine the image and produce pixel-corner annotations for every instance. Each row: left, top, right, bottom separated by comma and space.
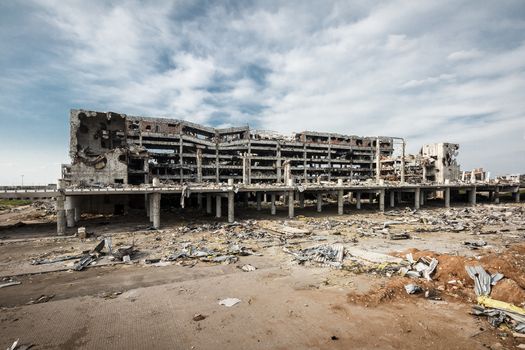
0, 198, 525, 349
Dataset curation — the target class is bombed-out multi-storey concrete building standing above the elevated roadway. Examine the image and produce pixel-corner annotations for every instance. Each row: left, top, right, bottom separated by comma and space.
62, 110, 393, 186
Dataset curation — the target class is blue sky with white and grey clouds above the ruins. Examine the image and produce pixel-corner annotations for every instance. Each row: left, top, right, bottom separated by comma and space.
0, 0, 525, 184
